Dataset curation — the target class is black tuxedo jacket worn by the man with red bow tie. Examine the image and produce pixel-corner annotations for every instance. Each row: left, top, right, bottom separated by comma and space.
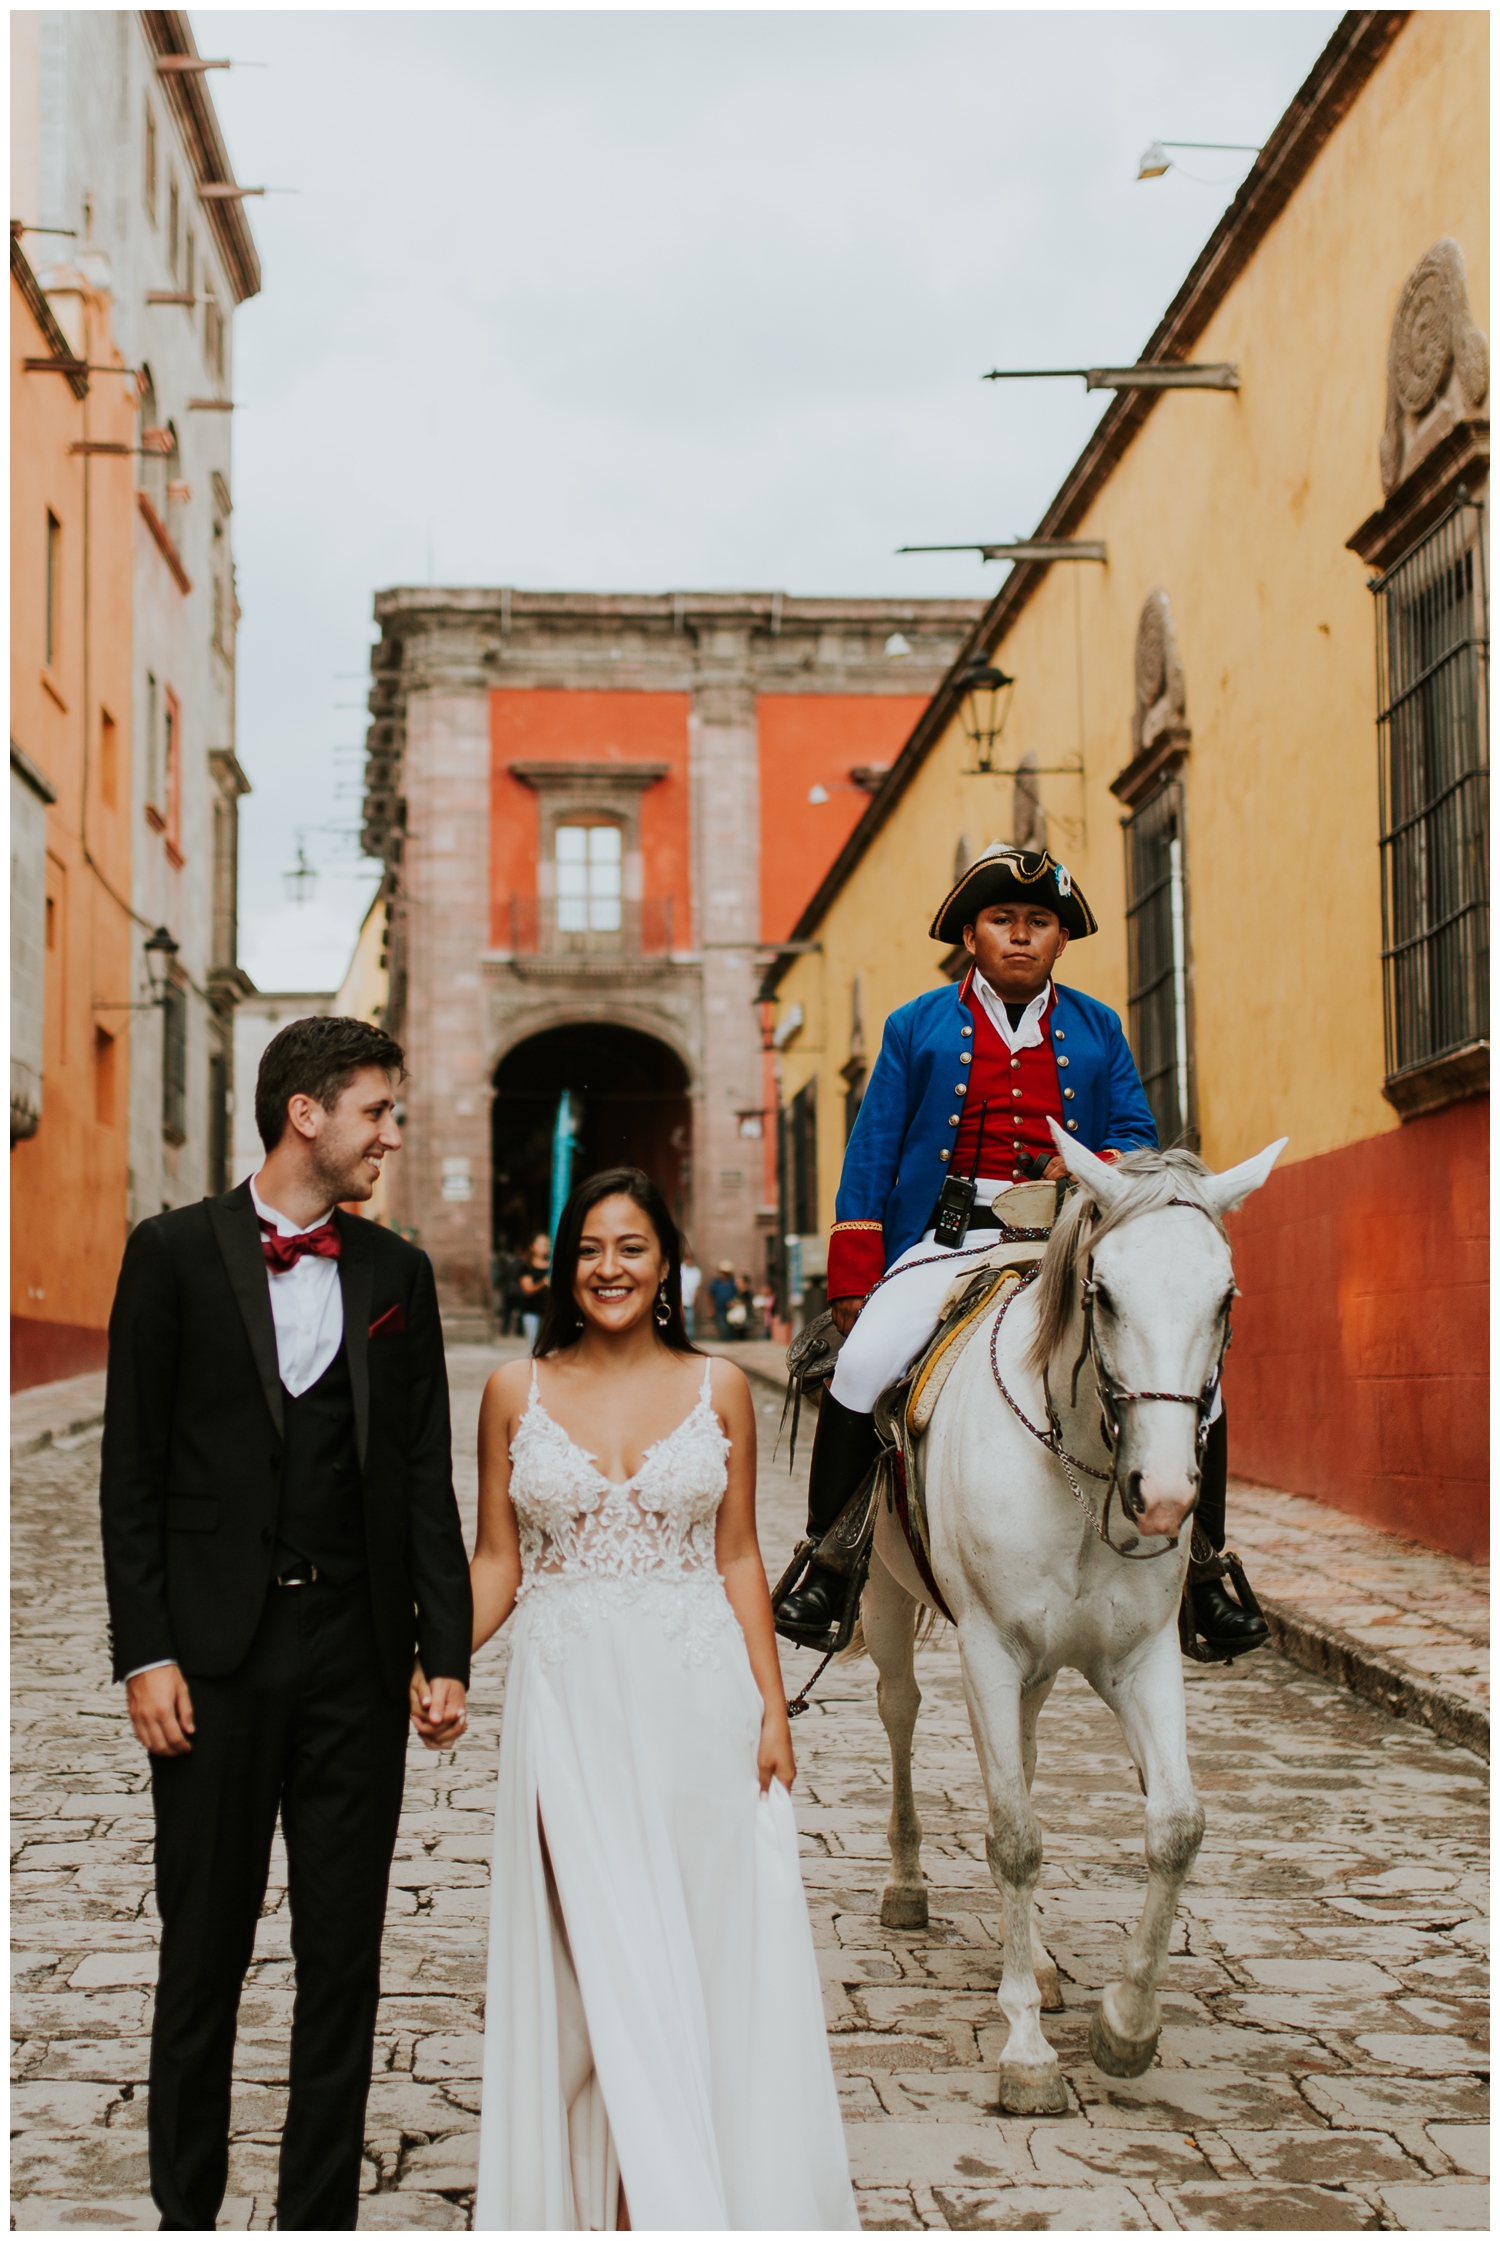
99, 1183, 471, 1694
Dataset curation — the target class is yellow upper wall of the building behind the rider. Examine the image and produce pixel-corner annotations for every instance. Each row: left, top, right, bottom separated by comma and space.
778, 11, 1489, 1224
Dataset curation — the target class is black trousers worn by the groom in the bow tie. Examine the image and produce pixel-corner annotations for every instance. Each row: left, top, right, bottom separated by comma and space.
148, 1580, 406, 2232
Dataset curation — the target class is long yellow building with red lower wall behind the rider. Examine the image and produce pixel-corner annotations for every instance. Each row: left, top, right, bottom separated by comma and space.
767, 11, 1489, 1555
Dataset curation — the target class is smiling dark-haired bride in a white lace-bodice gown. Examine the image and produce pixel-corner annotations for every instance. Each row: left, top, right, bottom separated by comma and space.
473, 1168, 859, 2232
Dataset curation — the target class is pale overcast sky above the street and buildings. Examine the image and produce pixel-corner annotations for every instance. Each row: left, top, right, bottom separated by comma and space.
193, 9, 1339, 988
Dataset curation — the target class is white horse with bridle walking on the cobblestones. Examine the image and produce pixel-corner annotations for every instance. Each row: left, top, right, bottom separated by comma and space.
861, 1125, 1287, 2116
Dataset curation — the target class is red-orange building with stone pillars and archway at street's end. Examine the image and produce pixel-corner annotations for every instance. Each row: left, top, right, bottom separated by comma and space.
365, 592, 980, 1315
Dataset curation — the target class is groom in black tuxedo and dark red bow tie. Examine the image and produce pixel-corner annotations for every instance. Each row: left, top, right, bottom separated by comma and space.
101, 1020, 471, 2232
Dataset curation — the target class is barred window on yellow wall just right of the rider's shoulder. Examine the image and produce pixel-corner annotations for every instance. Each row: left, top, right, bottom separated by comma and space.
1126, 780, 1195, 1145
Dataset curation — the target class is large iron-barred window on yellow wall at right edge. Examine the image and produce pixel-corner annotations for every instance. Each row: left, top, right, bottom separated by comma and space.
1374, 491, 1489, 1082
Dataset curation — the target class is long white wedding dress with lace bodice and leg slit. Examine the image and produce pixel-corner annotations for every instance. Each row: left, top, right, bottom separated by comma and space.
473, 1367, 859, 2232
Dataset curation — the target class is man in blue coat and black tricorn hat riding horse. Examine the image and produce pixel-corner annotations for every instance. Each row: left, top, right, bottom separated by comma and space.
776, 849, 1267, 1656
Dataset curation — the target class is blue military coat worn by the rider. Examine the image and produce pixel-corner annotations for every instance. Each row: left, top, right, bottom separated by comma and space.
834, 982, 1157, 1268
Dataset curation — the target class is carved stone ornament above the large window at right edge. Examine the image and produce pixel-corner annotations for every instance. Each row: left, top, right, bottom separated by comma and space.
1381, 240, 1489, 498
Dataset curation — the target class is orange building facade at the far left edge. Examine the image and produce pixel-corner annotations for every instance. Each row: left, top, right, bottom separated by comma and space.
11, 238, 138, 1387
